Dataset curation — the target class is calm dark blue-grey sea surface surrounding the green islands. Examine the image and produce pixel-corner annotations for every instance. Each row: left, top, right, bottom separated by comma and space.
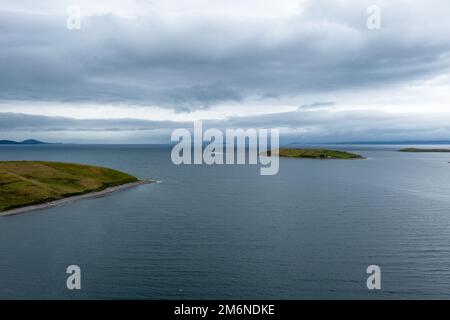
0, 145, 450, 299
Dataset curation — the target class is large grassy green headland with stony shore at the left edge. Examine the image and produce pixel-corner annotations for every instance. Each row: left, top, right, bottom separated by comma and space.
0, 161, 153, 215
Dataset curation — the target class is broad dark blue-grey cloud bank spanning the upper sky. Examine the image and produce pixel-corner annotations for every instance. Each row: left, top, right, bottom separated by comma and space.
0, 0, 450, 111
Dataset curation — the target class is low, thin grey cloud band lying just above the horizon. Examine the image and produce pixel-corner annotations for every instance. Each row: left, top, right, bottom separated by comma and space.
0, 110, 450, 143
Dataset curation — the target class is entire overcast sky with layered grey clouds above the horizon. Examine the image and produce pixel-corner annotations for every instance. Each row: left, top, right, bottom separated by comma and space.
0, 0, 450, 143
